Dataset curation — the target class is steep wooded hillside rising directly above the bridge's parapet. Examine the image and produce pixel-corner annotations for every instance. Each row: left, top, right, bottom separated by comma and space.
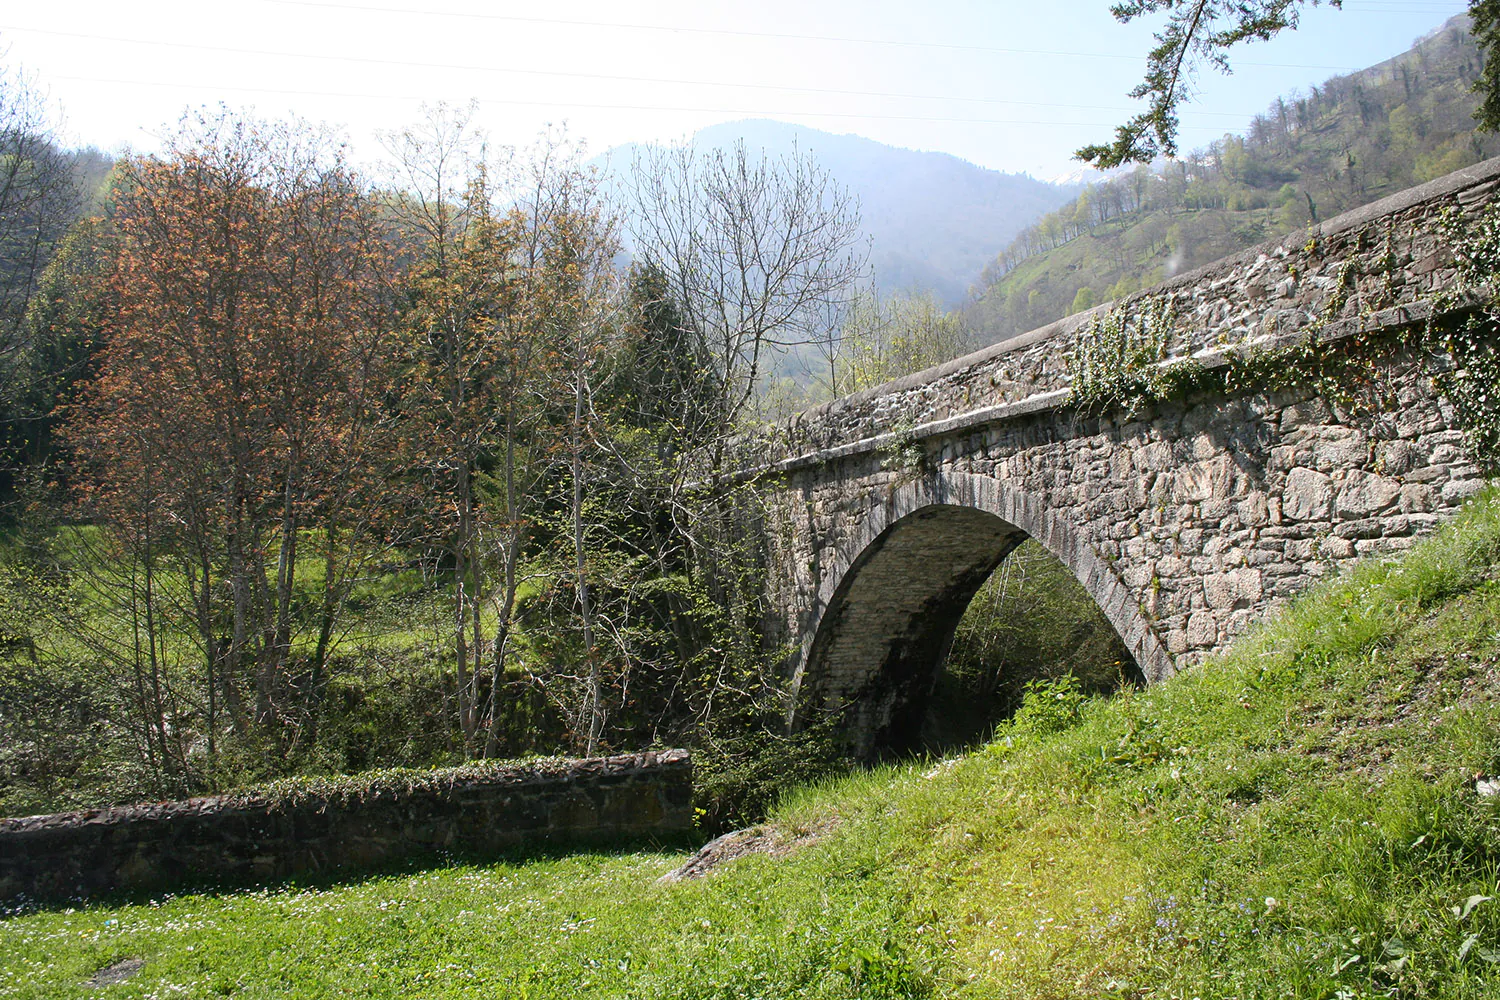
969, 16, 1500, 343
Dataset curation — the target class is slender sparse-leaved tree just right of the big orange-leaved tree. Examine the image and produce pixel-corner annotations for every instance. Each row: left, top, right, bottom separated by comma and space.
386, 105, 537, 754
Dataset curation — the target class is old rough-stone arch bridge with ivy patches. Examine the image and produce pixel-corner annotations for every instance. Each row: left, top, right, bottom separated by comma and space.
741, 159, 1500, 756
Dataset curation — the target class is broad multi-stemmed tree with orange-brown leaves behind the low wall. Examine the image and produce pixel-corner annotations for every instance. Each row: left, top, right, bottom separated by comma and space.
65, 112, 393, 763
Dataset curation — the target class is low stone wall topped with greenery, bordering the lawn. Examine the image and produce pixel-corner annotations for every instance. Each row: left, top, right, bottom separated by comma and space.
0, 750, 693, 900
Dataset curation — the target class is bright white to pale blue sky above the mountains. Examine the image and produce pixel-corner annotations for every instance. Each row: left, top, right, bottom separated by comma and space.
0, 0, 1467, 178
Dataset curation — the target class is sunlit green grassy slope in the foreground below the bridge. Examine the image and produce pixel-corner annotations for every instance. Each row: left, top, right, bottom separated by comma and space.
0, 496, 1500, 999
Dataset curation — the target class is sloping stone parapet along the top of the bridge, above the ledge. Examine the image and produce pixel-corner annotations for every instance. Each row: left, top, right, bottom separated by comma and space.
731, 157, 1500, 472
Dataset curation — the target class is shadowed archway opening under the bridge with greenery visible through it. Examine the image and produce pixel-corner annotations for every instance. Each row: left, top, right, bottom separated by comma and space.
797, 496, 1154, 757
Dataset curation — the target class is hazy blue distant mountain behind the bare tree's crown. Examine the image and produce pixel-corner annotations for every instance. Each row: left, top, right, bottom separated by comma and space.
600, 120, 1079, 306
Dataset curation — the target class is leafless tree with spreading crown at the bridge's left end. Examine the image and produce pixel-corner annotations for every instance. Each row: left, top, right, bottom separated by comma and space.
612, 142, 866, 749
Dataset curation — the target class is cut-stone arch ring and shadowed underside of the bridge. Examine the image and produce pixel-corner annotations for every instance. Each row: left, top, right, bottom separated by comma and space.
791, 471, 1173, 757
